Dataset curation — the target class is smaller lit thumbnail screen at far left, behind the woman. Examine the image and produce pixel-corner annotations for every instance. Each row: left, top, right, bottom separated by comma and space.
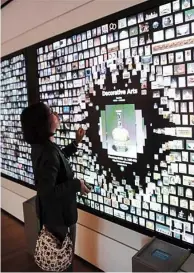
0, 54, 34, 184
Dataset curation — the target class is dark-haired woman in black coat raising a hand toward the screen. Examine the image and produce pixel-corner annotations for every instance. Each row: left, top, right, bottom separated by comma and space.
21, 103, 89, 271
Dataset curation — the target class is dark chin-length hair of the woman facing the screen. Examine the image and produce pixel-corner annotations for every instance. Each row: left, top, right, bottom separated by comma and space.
20, 102, 53, 144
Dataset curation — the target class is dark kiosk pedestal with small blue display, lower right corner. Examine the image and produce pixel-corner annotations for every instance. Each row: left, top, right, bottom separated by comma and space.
132, 237, 190, 272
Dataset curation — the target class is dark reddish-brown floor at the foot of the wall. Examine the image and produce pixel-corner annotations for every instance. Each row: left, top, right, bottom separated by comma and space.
1, 211, 100, 272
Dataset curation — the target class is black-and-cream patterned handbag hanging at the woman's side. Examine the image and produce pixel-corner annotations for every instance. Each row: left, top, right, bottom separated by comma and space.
34, 226, 73, 272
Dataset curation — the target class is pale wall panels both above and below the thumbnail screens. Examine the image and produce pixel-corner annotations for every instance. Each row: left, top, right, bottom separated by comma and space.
1, 0, 152, 271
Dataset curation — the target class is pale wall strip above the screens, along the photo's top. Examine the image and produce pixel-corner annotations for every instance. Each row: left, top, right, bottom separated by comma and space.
1, 0, 145, 56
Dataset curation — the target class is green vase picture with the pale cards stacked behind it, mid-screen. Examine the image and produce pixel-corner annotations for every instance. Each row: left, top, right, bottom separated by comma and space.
100, 104, 139, 158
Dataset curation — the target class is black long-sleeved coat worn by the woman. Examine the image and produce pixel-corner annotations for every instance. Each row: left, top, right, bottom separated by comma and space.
31, 141, 81, 226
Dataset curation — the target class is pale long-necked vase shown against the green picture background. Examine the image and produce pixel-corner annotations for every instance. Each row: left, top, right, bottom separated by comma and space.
112, 110, 130, 153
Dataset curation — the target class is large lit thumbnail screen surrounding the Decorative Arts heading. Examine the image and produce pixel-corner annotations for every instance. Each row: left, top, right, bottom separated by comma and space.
37, 0, 194, 244
